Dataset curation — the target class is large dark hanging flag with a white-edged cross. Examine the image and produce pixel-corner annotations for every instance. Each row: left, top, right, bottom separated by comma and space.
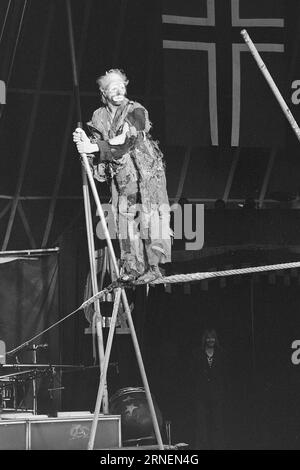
162, 0, 287, 147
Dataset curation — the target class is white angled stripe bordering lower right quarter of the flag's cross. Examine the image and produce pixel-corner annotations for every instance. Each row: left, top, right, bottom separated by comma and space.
231, 44, 284, 147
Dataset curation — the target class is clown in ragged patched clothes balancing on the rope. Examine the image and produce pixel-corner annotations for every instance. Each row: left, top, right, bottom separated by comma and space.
73, 69, 171, 282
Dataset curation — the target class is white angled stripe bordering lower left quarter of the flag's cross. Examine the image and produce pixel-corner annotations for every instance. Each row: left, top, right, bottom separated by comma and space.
163, 40, 219, 145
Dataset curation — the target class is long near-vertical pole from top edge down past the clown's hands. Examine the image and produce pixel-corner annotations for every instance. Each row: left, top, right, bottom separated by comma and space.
66, 0, 108, 413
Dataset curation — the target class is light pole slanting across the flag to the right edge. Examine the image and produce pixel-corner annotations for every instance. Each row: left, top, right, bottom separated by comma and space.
241, 29, 300, 140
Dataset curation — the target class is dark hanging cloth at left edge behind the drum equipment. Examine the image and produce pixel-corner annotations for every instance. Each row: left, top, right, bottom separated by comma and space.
0, 253, 60, 412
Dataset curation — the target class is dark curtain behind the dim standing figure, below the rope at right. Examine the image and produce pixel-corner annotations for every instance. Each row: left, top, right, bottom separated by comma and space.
145, 275, 300, 449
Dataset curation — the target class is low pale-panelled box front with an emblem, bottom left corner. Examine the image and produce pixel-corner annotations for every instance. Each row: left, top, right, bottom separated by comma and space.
0, 415, 121, 450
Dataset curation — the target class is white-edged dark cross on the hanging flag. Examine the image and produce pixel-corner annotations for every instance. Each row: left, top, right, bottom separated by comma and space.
162, 0, 284, 147
